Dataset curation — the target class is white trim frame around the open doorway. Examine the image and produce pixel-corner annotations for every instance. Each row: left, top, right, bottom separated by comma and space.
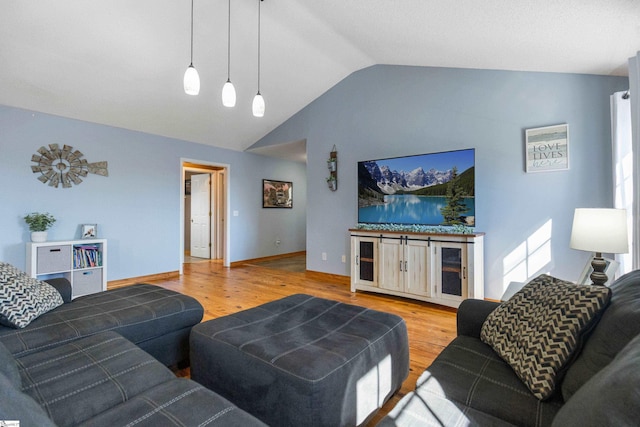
178, 157, 231, 274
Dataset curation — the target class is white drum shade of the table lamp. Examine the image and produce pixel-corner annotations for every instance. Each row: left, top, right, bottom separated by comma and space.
569, 208, 629, 254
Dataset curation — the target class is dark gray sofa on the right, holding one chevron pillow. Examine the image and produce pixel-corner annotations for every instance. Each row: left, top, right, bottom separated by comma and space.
378, 270, 640, 427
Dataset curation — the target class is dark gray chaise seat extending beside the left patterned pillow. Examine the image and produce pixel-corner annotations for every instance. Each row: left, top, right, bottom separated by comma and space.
0, 284, 204, 357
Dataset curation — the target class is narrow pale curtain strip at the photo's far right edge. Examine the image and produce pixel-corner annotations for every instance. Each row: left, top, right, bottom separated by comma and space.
629, 52, 640, 270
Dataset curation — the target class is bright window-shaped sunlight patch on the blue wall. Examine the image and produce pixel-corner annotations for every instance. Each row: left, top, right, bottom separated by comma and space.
502, 219, 552, 290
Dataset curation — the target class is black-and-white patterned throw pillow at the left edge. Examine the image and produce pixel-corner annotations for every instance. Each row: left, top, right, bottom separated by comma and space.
0, 262, 64, 328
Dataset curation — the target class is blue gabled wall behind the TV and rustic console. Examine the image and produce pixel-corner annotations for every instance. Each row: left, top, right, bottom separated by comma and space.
254, 65, 628, 298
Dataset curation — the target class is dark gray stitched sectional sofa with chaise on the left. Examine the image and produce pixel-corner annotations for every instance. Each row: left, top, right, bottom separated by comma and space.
0, 279, 264, 427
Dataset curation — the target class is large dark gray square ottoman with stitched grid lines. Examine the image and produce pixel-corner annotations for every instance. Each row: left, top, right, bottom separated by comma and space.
190, 294, 409, 426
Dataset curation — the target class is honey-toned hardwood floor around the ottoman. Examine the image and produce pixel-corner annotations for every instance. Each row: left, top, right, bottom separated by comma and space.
121, 261, 456, 425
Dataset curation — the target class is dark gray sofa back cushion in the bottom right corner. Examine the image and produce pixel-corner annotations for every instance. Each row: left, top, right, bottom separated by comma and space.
553, 335, 640, 427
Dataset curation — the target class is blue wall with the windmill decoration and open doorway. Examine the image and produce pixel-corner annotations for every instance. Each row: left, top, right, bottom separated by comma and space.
0, 106, 307, 280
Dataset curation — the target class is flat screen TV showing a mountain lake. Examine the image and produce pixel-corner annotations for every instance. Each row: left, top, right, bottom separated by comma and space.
358, 148, 475, 227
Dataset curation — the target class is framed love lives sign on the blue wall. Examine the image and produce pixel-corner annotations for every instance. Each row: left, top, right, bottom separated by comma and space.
525, 124, 569, 173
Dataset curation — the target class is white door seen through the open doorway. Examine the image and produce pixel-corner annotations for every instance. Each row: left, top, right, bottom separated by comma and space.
191, 173, 211, 258
